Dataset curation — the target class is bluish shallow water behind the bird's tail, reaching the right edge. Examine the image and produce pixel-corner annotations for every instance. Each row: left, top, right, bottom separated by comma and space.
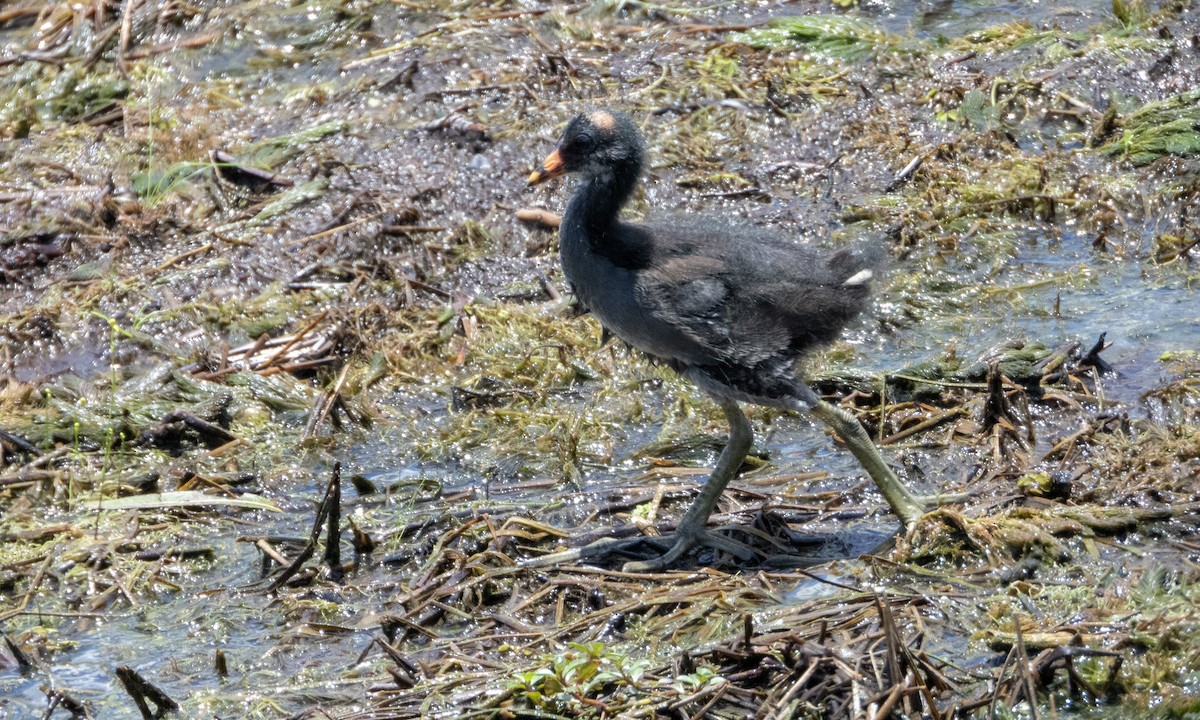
873, 228, 1200, 405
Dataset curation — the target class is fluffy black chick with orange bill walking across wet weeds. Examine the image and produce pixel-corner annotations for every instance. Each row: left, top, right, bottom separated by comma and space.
528, 108, 942, 571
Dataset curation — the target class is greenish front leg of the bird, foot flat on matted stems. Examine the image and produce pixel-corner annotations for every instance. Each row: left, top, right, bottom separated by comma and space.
624, 395, 754, 572
